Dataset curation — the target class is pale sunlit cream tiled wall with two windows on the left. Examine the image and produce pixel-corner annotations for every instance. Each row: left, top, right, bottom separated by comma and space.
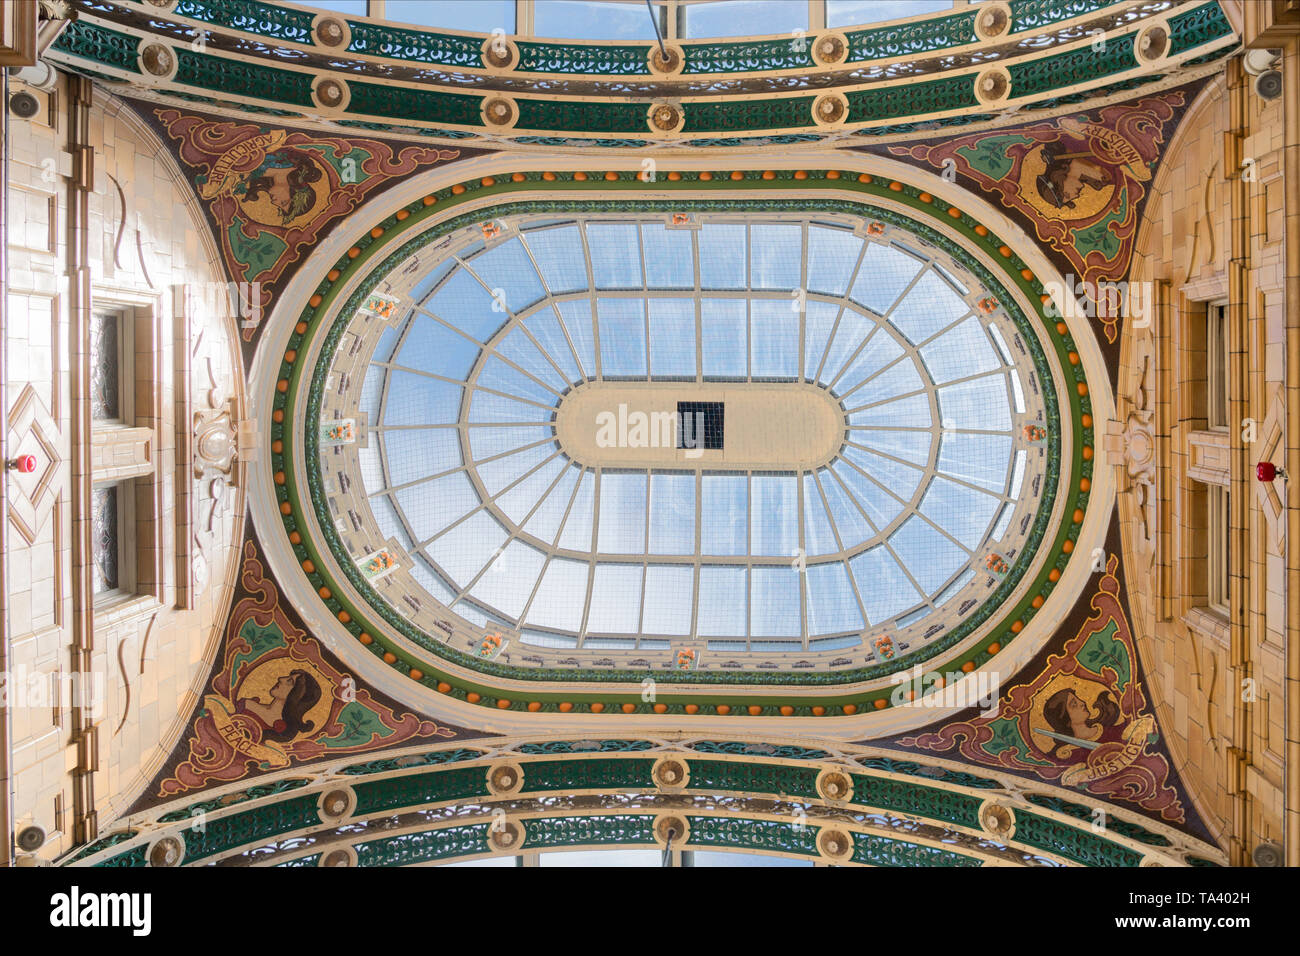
4, 83, 243, 857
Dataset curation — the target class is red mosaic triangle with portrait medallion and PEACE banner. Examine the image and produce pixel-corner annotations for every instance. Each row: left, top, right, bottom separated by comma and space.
140, 540, 477, 805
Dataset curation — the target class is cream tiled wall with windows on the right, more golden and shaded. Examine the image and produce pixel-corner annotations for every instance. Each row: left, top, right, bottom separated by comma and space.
1119, 65, 1297, 862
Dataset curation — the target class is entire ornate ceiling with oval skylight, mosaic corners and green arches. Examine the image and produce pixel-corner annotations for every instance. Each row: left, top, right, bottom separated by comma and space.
32, 0, 1235, 865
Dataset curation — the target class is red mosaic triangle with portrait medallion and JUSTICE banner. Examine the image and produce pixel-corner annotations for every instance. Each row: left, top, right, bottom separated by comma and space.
897, 554, 1200, 830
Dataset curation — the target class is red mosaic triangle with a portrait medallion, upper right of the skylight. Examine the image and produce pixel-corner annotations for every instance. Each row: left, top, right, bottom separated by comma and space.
888, 90, 1191, 345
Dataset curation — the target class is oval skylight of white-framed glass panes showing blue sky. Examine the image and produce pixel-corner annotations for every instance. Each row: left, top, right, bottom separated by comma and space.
332, 213, 1044, 653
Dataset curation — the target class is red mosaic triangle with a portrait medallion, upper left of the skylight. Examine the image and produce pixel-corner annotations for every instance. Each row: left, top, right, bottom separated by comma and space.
148, 109, 465, 353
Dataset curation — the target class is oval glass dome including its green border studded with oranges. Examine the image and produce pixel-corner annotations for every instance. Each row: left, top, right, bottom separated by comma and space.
263, 173, 1091, 714
